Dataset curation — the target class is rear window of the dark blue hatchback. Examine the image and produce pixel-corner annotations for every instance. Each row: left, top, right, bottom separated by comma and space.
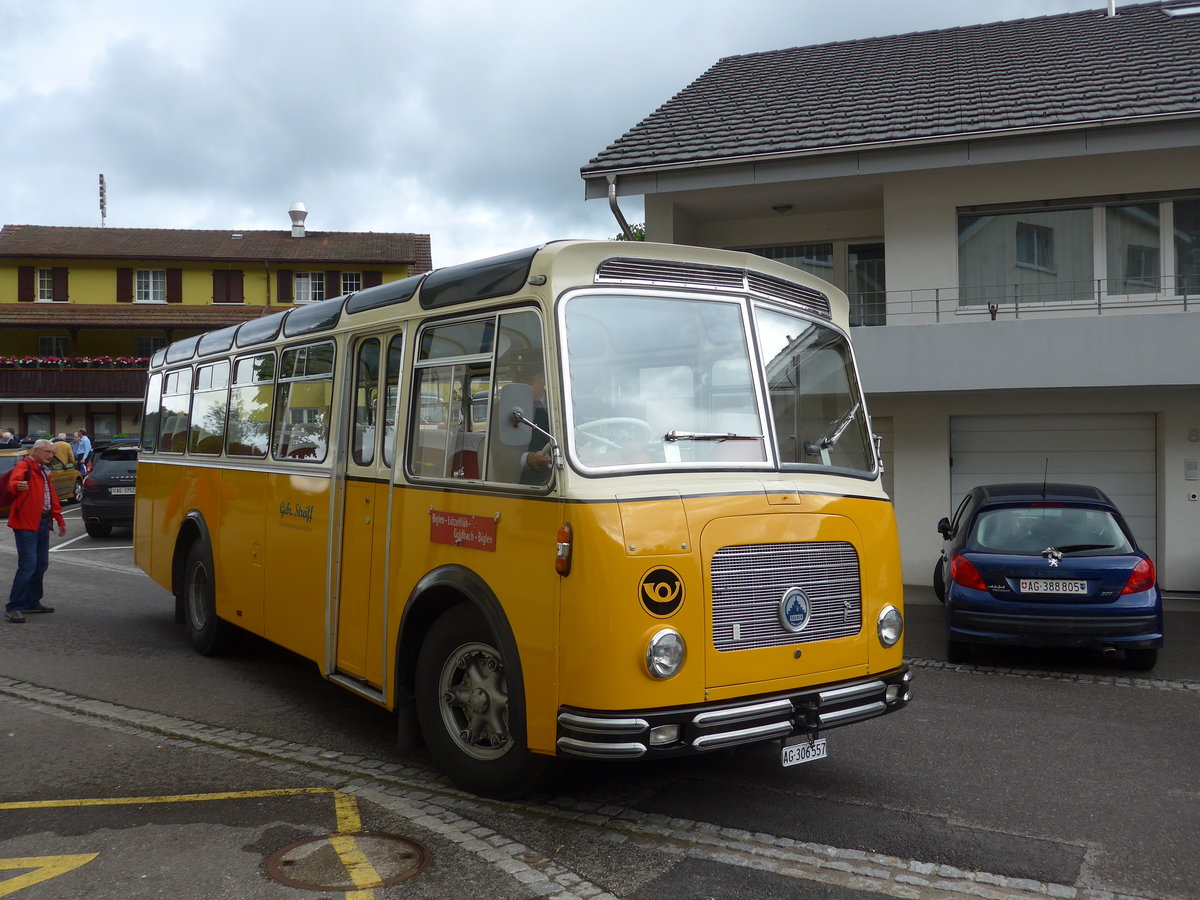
966, 506, 1133, 556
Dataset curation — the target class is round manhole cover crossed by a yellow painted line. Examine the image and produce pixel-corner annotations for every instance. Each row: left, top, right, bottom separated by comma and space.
266, 834, 430, 890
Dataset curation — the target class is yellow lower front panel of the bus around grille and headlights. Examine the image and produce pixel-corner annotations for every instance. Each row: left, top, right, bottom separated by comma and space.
560, 491, 904, 710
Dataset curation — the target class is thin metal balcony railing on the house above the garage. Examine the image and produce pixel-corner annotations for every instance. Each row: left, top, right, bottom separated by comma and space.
850, 275, 1200, 325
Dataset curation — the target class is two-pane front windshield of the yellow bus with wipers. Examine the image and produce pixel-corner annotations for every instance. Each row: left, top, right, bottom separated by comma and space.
563, 292, 875, 474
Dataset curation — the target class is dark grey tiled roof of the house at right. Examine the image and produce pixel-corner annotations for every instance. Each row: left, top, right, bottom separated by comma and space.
582, 0, 1200, 178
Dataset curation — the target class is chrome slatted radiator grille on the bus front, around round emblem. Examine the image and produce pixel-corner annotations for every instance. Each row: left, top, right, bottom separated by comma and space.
710, 541, 863, 650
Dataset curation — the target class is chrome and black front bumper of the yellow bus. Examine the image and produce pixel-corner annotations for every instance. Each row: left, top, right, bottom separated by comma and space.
557, 666, 912, 760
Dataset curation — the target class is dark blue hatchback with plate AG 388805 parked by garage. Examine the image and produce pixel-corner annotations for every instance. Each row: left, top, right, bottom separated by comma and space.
934, 484, 1163, 670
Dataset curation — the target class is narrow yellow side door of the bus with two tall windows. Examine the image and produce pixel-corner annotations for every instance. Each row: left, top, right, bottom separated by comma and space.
330, 332, 404, 694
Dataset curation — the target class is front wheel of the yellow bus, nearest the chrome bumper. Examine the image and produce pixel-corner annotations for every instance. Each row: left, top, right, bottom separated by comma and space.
416, 604, 557, 799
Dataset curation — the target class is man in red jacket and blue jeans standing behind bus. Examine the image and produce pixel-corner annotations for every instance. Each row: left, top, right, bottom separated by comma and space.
5, 440, 67, 623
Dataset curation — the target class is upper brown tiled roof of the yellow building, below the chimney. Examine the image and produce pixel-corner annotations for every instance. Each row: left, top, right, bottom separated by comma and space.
0, 224, 433, 275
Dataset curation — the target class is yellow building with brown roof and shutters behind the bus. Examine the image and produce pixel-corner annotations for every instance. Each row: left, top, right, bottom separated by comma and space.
0, 218, 432, 439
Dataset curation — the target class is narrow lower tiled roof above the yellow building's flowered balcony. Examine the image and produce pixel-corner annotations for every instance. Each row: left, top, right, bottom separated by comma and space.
0, 304, 270, 329
